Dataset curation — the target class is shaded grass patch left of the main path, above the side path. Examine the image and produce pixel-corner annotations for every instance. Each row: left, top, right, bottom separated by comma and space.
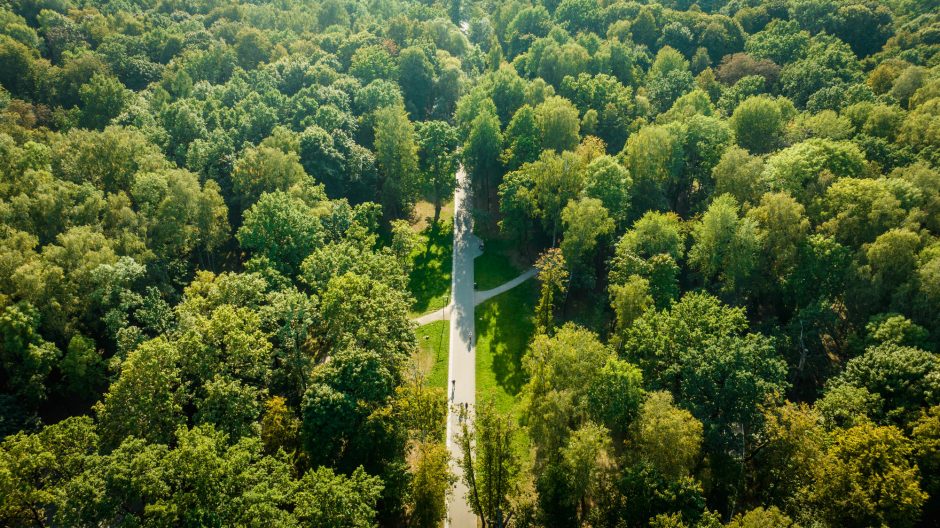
408, 222, 454, 317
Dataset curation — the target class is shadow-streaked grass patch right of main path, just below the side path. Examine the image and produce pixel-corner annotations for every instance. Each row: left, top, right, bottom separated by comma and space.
476, 282, 536, 396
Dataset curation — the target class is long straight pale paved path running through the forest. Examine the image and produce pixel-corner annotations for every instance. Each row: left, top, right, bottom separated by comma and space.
442, 167, 480, 528
